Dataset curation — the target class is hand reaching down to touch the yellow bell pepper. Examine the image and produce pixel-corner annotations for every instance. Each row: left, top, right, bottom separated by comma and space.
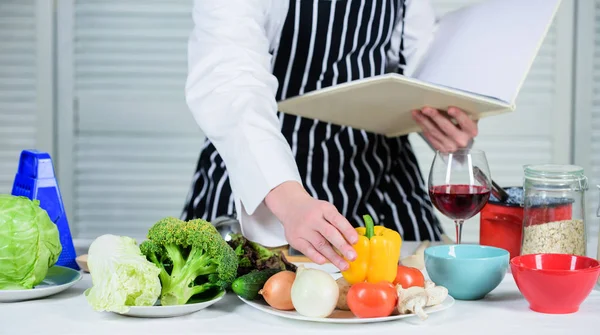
265, 182, 358, 271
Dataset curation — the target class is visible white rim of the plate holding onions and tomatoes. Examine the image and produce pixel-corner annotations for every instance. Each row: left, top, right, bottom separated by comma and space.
238, 295, 454, 323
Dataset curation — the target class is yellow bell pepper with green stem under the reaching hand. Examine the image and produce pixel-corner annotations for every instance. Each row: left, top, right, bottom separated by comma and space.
342, 215, 402, 285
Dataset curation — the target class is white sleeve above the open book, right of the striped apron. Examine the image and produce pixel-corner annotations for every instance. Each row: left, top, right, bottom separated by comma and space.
388, 0, 437, 77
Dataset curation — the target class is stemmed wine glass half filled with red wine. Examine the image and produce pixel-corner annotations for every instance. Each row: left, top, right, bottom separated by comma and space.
429, 149, 492, 244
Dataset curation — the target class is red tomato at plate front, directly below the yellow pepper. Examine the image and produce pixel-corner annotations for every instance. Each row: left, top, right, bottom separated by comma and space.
346, 282, 398, 318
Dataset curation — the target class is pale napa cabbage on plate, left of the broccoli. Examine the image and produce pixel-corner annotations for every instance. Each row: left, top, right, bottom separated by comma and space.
85, 234, 161, 313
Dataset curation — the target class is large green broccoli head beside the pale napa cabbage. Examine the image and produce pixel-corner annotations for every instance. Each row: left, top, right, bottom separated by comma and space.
140, 217, 238, 306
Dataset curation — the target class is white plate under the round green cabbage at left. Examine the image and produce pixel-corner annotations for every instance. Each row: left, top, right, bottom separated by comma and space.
0, 265, 81, 302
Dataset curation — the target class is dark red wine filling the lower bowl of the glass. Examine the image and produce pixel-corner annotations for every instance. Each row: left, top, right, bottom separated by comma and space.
429, 185, 490, 220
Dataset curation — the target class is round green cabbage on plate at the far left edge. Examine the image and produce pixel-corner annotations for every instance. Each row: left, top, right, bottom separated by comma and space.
0, 194, 62, 290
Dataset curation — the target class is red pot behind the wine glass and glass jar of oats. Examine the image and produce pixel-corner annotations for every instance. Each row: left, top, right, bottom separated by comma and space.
479, 187, 572, 259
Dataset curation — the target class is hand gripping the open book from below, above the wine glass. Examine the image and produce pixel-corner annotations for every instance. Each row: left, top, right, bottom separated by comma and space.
412, 107, 478, 152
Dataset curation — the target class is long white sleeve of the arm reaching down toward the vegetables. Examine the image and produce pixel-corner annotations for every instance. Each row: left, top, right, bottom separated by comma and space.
186, 0, 300, 246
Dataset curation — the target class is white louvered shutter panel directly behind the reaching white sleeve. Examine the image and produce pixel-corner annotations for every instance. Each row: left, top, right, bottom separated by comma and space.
73, 0, 203, 238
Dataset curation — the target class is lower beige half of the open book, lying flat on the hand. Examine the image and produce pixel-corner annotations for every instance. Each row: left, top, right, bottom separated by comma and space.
277, 73, 512, 137
